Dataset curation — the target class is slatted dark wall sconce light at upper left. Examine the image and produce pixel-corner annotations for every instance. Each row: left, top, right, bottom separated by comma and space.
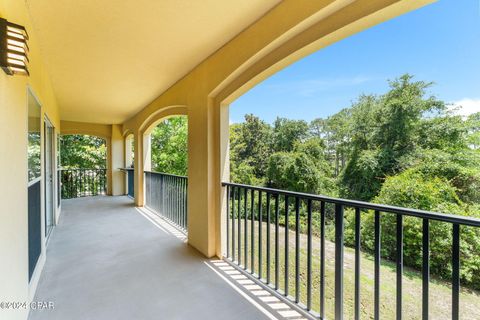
0, 18, 30, 76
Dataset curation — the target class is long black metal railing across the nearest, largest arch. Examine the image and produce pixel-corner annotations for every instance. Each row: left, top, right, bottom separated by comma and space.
222, 182, 480, 320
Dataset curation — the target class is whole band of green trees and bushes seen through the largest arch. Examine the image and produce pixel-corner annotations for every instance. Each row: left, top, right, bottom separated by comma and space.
230, 75, 480, 288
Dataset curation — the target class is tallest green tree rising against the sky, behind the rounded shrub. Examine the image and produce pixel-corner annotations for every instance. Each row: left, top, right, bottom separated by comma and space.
340, 74, 445, 200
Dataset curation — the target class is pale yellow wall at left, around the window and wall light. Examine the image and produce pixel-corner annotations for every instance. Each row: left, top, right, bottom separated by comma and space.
0, 0, 60, 319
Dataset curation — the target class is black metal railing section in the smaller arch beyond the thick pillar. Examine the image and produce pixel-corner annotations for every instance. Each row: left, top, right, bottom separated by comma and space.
145, 171, 188, 231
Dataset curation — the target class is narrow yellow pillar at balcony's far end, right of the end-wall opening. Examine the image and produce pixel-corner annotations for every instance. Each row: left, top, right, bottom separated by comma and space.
110, 124, 125, 196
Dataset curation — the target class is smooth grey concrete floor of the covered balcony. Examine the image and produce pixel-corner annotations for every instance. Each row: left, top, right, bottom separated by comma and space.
29, 197, 299, 320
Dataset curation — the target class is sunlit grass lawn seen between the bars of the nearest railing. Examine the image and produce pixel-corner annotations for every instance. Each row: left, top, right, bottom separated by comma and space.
229, 221, 480, 319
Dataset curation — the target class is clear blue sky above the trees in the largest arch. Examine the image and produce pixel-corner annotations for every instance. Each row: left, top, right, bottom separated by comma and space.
230, 0, 480, 123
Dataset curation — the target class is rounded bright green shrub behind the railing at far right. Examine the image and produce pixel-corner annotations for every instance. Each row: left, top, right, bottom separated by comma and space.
345, 169, 480, 289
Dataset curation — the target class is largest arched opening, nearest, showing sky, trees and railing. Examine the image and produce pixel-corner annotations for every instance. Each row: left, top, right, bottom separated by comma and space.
220, 2, 480, 318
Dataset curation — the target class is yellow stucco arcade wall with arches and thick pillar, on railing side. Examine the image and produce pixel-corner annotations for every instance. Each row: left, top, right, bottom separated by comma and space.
123, 0, 434, 257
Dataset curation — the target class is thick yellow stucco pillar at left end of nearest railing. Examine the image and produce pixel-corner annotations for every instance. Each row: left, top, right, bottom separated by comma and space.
188, 105, 228, 257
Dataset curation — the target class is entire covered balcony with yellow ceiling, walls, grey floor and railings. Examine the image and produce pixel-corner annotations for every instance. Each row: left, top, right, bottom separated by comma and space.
0, 0, 454, 320
